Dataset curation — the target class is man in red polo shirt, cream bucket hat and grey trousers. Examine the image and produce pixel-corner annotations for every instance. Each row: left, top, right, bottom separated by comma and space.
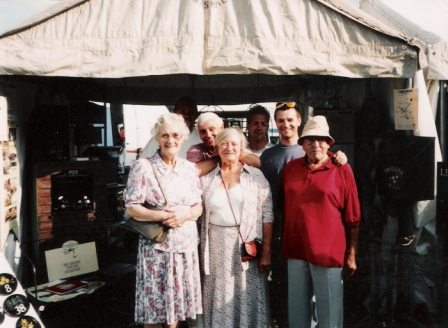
282, 116, 360, 328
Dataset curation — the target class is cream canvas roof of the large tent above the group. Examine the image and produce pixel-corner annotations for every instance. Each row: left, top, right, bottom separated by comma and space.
0, 0, 425, 78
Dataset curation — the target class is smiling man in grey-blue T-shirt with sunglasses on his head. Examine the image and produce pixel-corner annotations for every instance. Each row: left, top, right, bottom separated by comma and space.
260, 101, 347, 327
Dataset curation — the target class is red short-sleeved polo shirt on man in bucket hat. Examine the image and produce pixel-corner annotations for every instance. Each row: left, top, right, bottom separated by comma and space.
282, 157, 360, 267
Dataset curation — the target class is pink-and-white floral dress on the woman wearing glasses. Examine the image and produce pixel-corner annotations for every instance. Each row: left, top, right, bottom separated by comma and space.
125, 153, 202, 324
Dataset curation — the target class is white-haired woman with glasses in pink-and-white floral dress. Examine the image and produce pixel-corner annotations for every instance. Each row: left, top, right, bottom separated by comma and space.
125, 113, 202, 327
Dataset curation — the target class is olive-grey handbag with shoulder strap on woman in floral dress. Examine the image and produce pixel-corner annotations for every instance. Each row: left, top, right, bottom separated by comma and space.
123, 159, 169, 243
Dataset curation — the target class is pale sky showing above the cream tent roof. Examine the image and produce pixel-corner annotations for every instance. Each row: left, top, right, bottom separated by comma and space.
0, 0, 360, 34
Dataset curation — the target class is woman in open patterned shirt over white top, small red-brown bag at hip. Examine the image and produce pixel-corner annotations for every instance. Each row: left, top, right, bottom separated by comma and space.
201, 128, 273, 328
